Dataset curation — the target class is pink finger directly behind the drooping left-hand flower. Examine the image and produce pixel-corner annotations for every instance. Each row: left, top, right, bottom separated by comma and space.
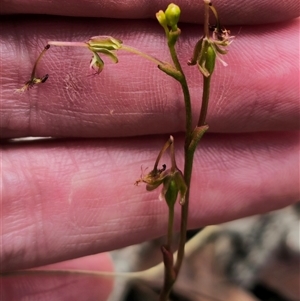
0, 17, 300, 138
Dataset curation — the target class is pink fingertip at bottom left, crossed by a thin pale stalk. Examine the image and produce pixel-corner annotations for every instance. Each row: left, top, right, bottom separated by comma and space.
0, 254, 113, 301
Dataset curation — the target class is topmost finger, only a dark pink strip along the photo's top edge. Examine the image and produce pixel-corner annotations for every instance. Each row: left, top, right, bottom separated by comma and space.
1, 0, 300, 24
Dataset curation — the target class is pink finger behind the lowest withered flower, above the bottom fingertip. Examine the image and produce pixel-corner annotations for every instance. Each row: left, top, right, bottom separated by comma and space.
1, 133, 299, 270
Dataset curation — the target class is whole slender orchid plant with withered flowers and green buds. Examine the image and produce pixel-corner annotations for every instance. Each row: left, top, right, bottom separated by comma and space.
18, 0, 233, 301
